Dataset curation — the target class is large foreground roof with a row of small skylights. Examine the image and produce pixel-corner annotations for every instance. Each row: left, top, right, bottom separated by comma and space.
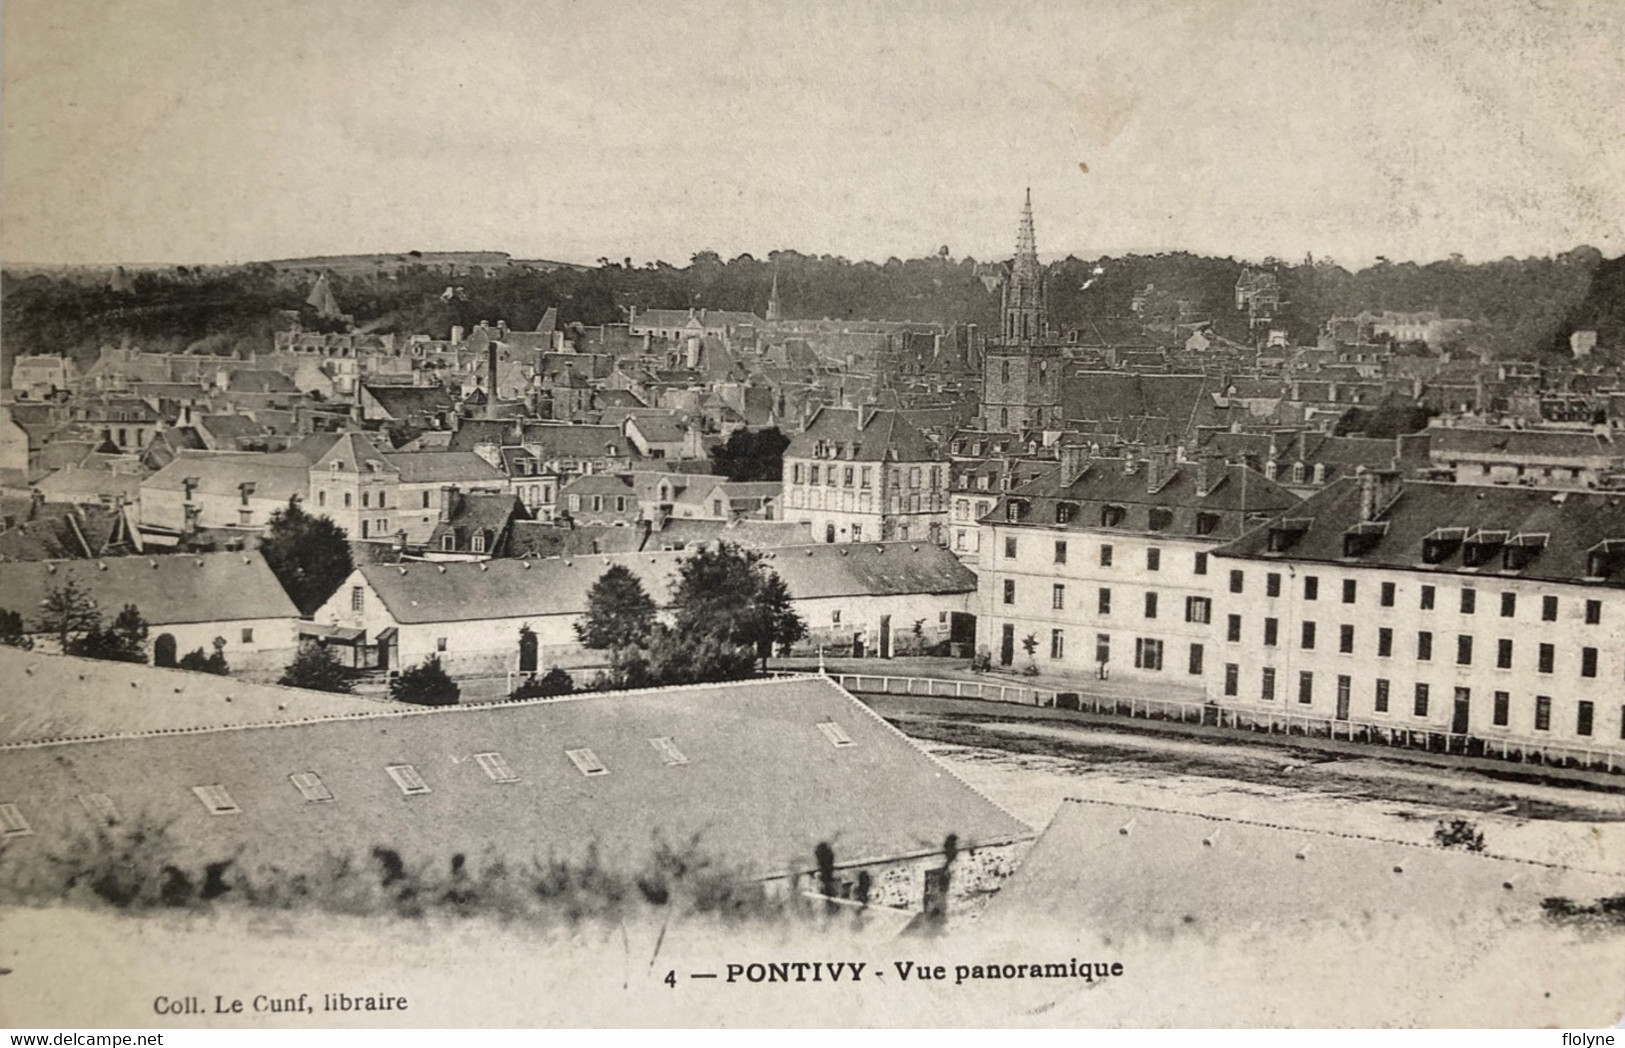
0, 678, 1032, 877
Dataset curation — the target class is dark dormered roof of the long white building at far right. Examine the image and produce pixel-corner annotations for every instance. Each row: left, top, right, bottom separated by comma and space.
1216, 478, 1625, 588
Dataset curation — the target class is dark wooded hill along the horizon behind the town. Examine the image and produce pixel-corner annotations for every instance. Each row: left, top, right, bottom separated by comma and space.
0, 247, 1625, 361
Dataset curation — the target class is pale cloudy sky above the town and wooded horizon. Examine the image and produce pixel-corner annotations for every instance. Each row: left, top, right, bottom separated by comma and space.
0, 0, 1625, 265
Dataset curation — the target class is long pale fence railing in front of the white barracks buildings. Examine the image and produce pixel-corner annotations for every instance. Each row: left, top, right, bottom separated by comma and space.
809, 673, 1625, 772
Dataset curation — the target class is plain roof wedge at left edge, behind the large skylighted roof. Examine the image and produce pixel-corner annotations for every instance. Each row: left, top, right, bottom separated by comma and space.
0, 647, 379, 746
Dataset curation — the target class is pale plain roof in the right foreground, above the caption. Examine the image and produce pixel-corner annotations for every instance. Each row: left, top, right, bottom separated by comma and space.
978, 799, 1625, 941
